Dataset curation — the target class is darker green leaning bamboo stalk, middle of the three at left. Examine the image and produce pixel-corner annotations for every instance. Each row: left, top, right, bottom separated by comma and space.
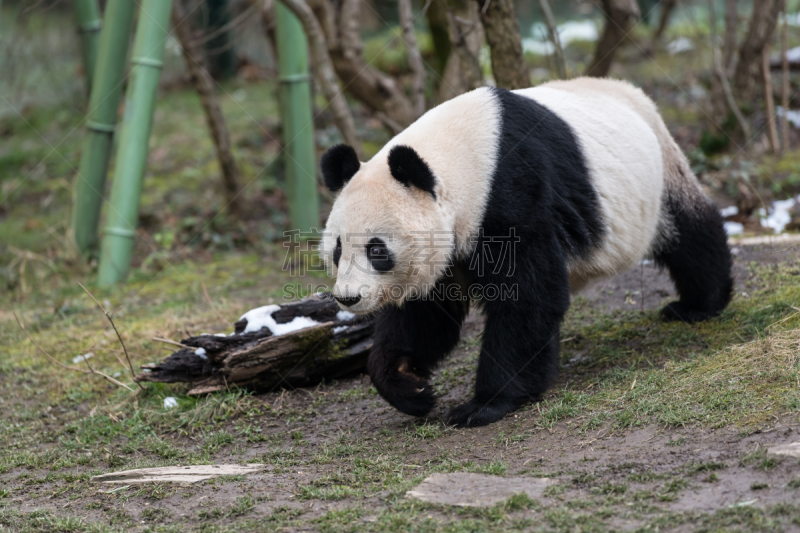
72, 0, 136, 254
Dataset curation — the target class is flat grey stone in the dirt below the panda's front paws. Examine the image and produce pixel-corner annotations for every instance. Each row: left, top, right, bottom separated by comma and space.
406, 473, 555, 507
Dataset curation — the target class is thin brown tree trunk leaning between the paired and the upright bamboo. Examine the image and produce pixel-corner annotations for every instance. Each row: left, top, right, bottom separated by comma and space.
172, 0, 242, 216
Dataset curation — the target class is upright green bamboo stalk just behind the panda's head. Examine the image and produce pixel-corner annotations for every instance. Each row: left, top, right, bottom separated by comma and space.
275, 2, 319, 232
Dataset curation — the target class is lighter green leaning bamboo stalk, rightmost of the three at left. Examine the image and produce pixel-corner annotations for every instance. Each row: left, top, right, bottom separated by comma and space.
98, 0, 172, 285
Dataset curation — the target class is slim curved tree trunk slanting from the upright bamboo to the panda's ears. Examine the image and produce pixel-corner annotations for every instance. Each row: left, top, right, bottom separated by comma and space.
280, 0, 364, 159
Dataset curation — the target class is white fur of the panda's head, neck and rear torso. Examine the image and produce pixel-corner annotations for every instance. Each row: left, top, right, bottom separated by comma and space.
323, 78, 701, 306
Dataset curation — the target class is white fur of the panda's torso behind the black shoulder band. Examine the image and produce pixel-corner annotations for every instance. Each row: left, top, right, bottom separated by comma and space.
516, 78, 664, 290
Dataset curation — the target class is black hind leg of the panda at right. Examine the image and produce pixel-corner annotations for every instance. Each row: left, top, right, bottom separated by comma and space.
654, 196, 733, 322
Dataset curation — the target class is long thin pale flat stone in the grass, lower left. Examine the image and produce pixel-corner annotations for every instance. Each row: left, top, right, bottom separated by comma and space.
91, 464, 266, 485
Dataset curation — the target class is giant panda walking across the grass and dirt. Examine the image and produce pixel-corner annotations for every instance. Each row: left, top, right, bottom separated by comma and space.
320, 78, 732, 427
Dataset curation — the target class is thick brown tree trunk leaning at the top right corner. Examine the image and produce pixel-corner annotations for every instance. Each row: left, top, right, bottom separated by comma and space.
732, 0, 782, 102
